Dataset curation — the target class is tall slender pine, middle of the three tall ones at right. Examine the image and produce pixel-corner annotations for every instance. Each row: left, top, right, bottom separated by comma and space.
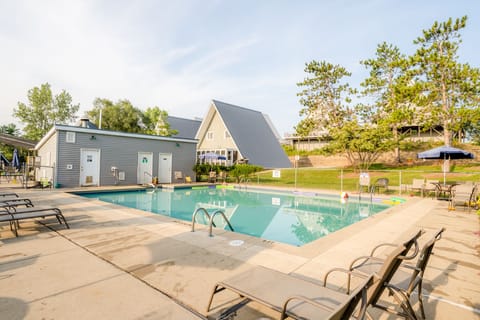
360, 42, 418, 162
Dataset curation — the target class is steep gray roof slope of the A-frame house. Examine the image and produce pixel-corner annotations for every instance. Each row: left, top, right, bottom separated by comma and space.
206, 100, 291, 168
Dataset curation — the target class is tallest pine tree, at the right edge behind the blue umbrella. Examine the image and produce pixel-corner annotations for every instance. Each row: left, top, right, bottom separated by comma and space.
414, 16, 480, 145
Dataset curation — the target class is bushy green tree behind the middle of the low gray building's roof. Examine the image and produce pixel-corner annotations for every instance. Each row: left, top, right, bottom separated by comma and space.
87, 98, 144, 133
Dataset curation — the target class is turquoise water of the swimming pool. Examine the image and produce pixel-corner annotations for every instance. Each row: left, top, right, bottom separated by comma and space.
80, 188, 389, 246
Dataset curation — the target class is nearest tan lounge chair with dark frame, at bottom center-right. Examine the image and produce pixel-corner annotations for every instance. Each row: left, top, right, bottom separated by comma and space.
207, 232, 421, 319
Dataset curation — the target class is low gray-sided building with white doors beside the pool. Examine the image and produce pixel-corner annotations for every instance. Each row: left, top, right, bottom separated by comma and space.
35, 125, 197, 187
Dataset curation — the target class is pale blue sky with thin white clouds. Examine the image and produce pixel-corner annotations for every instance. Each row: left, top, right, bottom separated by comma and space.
0, 0, 480, 135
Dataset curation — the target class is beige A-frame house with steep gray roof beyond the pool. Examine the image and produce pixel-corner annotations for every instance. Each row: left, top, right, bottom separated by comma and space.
195, 100, 291, 168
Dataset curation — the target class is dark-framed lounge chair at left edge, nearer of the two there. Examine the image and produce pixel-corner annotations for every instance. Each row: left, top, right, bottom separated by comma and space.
0, 207, 70, 237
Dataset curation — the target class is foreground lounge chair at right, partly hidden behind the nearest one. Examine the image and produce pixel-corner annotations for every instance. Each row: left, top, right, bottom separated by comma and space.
350, 228, 445, 319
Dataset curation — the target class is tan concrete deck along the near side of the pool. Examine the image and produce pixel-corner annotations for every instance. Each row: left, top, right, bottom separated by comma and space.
0, 185, 480, 320
